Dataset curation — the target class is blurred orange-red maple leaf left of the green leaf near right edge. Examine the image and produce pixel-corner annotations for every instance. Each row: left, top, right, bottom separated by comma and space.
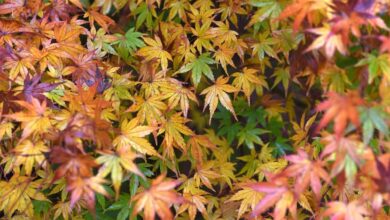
316, 92, 363, 137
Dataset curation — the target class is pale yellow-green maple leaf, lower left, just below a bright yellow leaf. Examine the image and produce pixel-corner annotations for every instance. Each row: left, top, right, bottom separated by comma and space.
96, 148, 145, 199
